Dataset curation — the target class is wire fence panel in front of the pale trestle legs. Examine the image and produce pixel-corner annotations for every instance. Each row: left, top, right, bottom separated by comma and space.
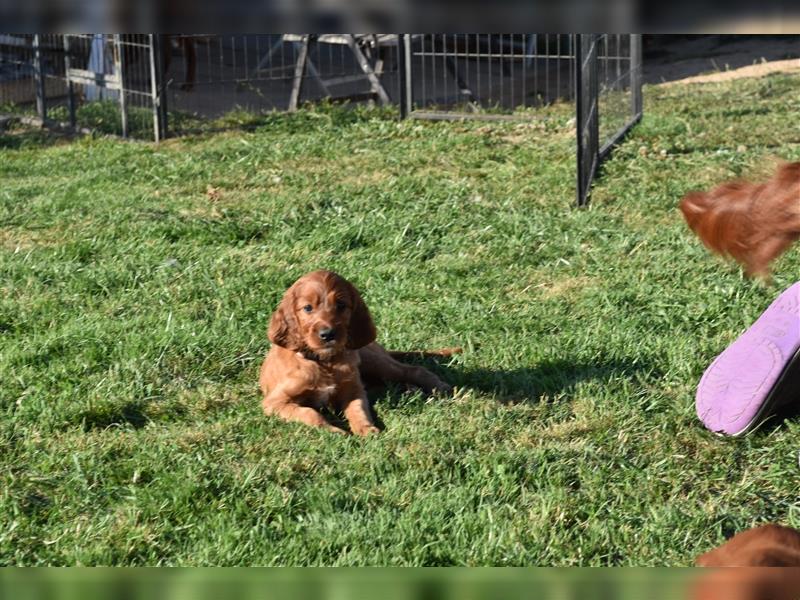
164, 34, 398, 132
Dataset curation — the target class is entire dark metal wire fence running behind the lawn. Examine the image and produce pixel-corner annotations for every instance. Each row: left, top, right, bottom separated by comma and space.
0, 34, 641, 205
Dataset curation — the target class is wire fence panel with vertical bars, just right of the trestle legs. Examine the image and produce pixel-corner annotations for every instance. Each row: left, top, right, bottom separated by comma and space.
404, 33, 575, 118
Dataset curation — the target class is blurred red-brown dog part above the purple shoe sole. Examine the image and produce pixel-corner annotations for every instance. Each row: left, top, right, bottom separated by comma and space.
680, 162, 800, 276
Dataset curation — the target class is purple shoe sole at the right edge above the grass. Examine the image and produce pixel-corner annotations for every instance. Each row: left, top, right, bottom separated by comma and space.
696, 283, 800, 436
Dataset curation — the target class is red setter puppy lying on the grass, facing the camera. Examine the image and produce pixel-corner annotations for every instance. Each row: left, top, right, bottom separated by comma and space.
260, 271, 458, 435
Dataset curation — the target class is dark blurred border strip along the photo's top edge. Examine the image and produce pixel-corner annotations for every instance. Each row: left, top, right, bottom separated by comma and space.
0, 0, 800, 33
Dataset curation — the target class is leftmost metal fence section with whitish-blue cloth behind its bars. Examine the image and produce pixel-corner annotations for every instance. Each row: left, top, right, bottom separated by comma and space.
0, 33, 166, 141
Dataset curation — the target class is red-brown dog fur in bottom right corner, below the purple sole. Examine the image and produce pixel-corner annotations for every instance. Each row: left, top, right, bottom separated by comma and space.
691, 525, 800, 600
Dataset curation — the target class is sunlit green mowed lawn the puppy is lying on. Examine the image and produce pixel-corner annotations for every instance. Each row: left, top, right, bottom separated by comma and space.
0, 75, 800, 565
